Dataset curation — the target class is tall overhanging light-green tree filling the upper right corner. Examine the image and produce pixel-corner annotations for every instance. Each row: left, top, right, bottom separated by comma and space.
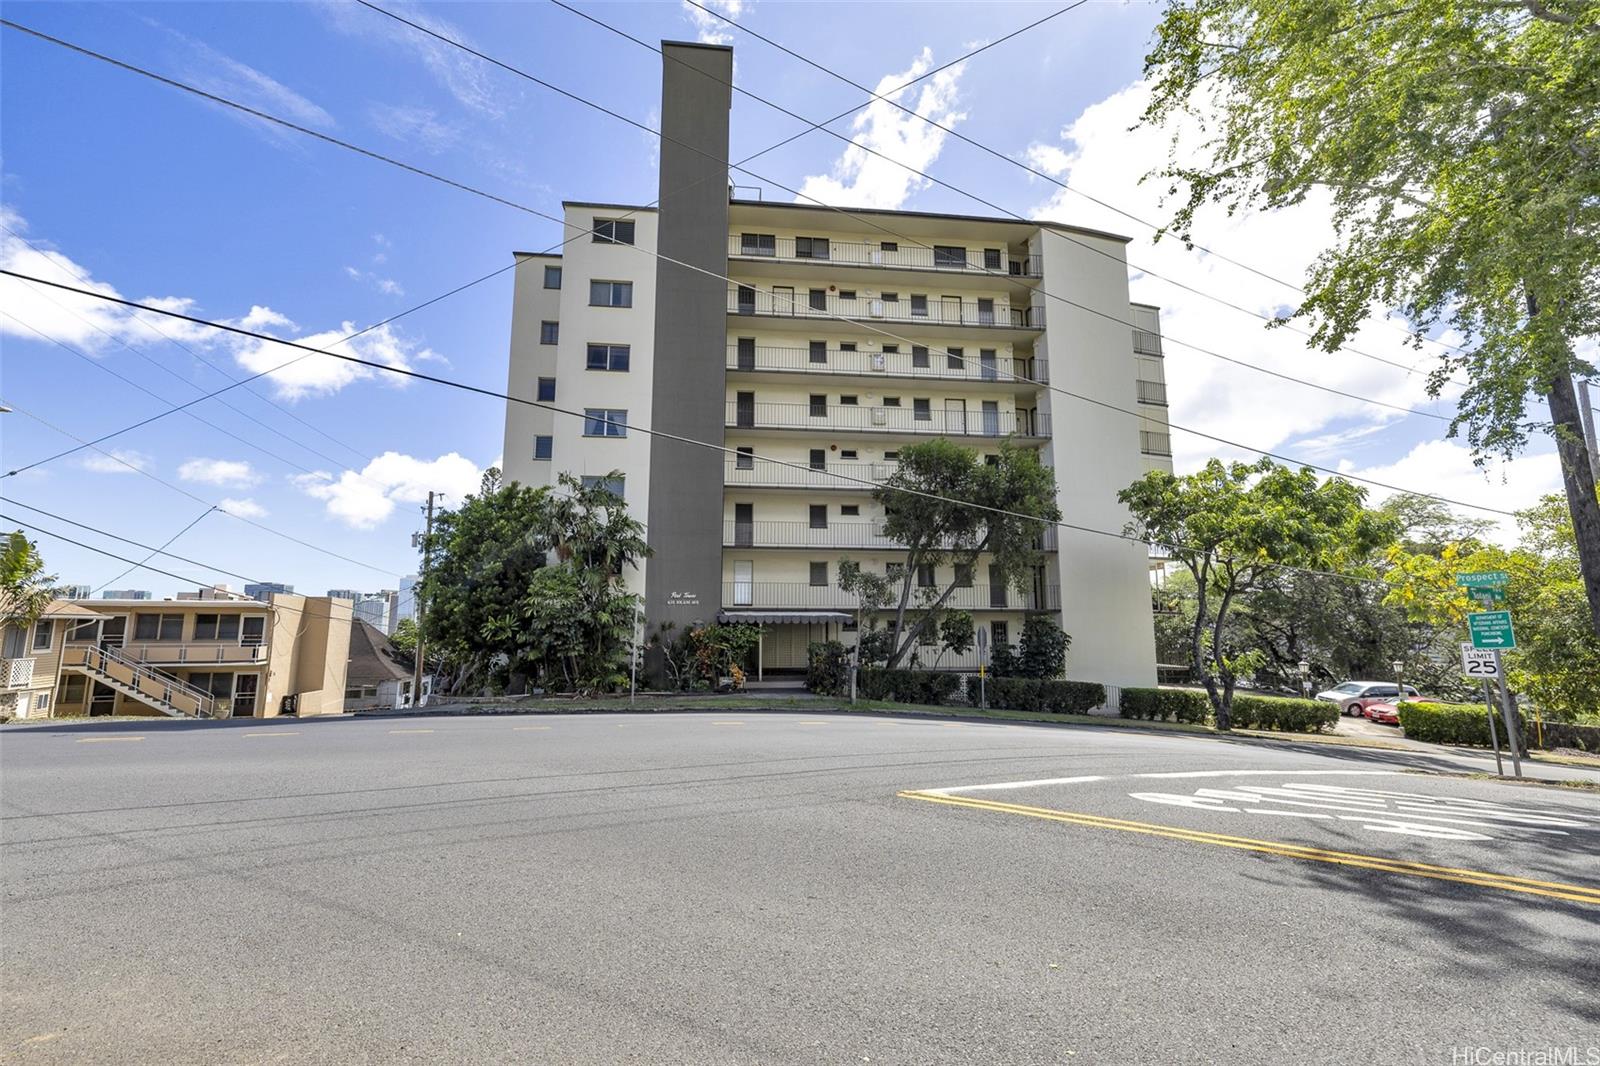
1146, 0, 1600, 632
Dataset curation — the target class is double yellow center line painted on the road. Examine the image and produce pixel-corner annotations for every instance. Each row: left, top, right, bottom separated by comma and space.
899, 789, 1600, 904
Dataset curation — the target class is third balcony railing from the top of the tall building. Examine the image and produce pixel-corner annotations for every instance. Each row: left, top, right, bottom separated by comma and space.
728, 344, 1048, 386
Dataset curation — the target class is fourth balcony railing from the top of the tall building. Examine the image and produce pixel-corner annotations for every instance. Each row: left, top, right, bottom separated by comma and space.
726, 400, 1050, 437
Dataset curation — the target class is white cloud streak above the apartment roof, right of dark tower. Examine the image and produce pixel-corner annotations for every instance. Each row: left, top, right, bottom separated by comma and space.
795, 48, 966, 210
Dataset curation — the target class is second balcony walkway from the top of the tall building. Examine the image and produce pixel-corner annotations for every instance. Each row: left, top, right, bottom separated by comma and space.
728, 285, 1045, 341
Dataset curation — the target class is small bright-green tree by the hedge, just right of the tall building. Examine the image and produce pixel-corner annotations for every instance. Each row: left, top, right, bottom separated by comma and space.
1117, 459, 1395, 728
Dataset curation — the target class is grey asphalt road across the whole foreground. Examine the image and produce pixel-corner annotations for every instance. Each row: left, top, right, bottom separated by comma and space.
0, 712, 1600, 1066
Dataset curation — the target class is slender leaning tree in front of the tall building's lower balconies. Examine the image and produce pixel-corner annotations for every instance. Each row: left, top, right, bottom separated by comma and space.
874, 437, 1061, 667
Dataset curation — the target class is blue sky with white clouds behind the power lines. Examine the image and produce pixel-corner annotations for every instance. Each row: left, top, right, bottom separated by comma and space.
0, 0, 1555, 592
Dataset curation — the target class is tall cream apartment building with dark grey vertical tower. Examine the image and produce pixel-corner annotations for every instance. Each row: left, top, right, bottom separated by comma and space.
504, 43, 1171, 685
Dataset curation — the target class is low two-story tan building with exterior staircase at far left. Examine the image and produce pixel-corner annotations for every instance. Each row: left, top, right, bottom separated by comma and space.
0, 589, 350, 717
